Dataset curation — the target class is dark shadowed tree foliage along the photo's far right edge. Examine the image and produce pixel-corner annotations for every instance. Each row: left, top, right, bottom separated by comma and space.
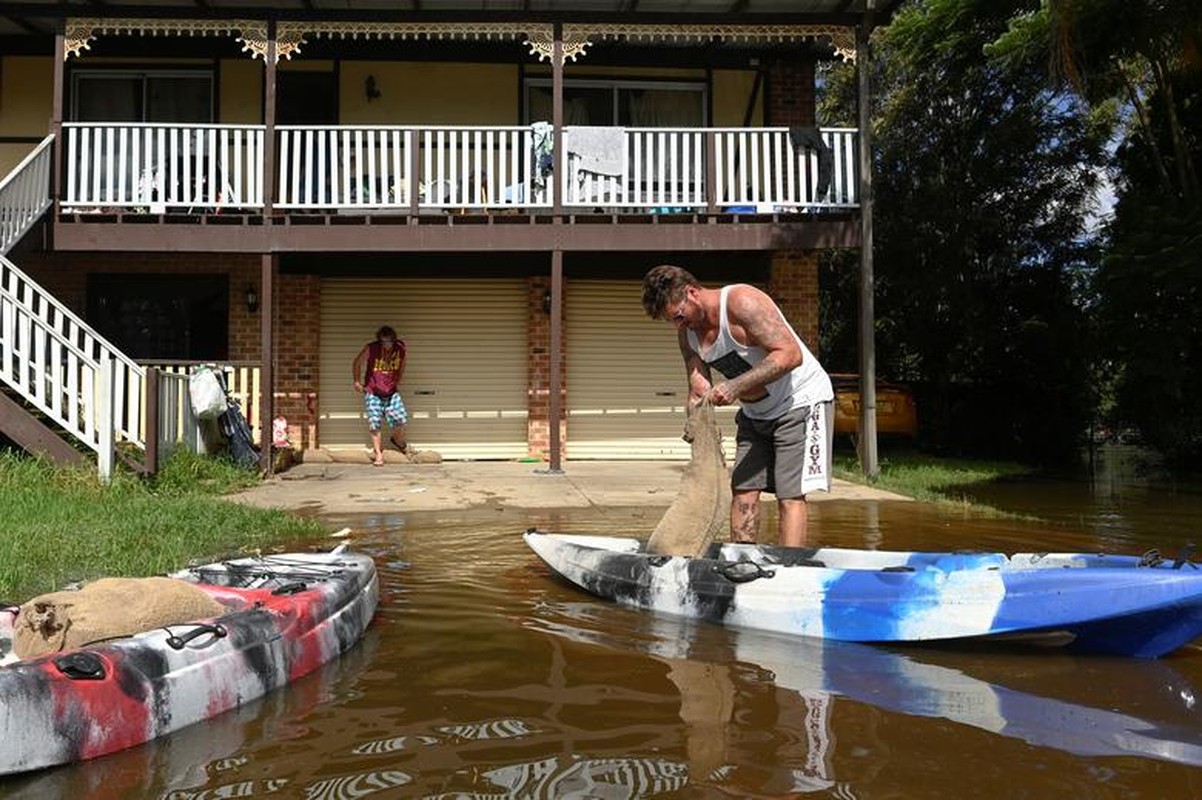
994, 0, 1202, 462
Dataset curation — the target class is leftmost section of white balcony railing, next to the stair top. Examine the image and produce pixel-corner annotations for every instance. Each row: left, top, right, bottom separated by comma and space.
63, 123, 264, 213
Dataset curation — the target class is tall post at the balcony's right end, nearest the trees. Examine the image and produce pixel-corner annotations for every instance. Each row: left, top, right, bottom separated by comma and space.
856, 12, 880, 478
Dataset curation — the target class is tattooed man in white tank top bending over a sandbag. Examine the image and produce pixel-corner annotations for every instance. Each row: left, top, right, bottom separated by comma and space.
643, 264, 834, 547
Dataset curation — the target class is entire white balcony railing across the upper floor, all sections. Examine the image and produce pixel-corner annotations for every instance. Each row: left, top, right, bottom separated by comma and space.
64, 124, 859, 214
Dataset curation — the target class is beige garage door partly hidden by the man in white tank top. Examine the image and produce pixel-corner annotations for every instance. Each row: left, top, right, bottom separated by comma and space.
565, 280, 736, 460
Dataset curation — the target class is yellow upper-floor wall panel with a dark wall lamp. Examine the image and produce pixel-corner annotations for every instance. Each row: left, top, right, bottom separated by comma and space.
339, 61, 519, 125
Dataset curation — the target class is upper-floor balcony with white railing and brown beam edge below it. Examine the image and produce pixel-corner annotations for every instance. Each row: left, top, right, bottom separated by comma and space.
56, 123, 858, 252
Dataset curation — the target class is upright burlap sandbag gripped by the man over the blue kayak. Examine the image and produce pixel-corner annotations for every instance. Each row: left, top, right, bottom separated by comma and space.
647, 402, 731, 556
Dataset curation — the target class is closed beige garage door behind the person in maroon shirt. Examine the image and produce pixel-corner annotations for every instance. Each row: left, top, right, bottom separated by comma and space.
319, 279, 528, 459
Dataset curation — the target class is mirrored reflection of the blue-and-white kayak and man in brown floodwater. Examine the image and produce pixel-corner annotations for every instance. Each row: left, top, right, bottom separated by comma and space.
537, 590, 1202, 778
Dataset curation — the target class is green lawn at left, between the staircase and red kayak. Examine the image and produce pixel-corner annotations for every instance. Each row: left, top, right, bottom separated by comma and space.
0, 453, 325, 602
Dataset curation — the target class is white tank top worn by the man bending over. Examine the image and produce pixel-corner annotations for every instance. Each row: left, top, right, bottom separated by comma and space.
685, 286, 834, 419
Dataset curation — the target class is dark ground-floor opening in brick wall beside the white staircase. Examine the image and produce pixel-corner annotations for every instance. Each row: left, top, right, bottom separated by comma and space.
88, 274, 230, 360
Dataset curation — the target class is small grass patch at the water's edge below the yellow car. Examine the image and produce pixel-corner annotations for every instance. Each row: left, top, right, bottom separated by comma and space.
834, 452, 1031, 514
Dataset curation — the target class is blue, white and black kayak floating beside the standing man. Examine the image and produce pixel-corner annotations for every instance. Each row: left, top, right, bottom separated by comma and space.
524, 531, 1202, 658
